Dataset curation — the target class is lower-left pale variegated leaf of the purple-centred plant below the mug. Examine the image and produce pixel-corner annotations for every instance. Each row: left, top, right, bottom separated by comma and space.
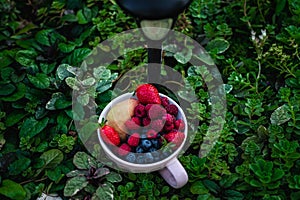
64, 176, 88, 197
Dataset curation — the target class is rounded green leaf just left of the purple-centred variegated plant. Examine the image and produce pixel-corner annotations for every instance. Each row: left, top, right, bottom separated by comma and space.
40, 149, 64, 169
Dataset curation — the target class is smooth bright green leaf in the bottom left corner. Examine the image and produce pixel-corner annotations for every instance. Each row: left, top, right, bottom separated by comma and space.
0, 179, 26, 200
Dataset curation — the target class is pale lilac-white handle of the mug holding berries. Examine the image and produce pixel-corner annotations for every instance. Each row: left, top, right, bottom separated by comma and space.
159, 158, 188, 189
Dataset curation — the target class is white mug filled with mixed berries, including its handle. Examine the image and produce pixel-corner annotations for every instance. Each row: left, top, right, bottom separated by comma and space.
98, 83, 188, 188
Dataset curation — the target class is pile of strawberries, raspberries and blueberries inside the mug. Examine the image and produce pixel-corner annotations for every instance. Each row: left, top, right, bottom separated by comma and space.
100, 84, 185, 164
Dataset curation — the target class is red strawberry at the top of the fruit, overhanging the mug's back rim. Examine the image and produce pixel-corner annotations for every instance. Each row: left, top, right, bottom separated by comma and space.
135, 83, 161, 105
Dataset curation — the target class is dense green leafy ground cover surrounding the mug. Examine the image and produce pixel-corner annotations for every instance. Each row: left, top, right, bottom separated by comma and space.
0, 0, 300, 200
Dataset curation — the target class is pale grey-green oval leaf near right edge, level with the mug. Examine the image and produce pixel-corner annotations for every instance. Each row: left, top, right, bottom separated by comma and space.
270, 104, 291, 125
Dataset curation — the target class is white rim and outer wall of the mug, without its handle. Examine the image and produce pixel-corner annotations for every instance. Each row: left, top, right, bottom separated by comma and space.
97, 92, 187, 171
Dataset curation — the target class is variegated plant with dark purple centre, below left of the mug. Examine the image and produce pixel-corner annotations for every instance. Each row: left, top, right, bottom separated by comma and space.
64, 152, 122, 199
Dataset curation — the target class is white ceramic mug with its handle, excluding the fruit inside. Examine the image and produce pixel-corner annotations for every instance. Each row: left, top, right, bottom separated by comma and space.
97, 93, 188, 188
